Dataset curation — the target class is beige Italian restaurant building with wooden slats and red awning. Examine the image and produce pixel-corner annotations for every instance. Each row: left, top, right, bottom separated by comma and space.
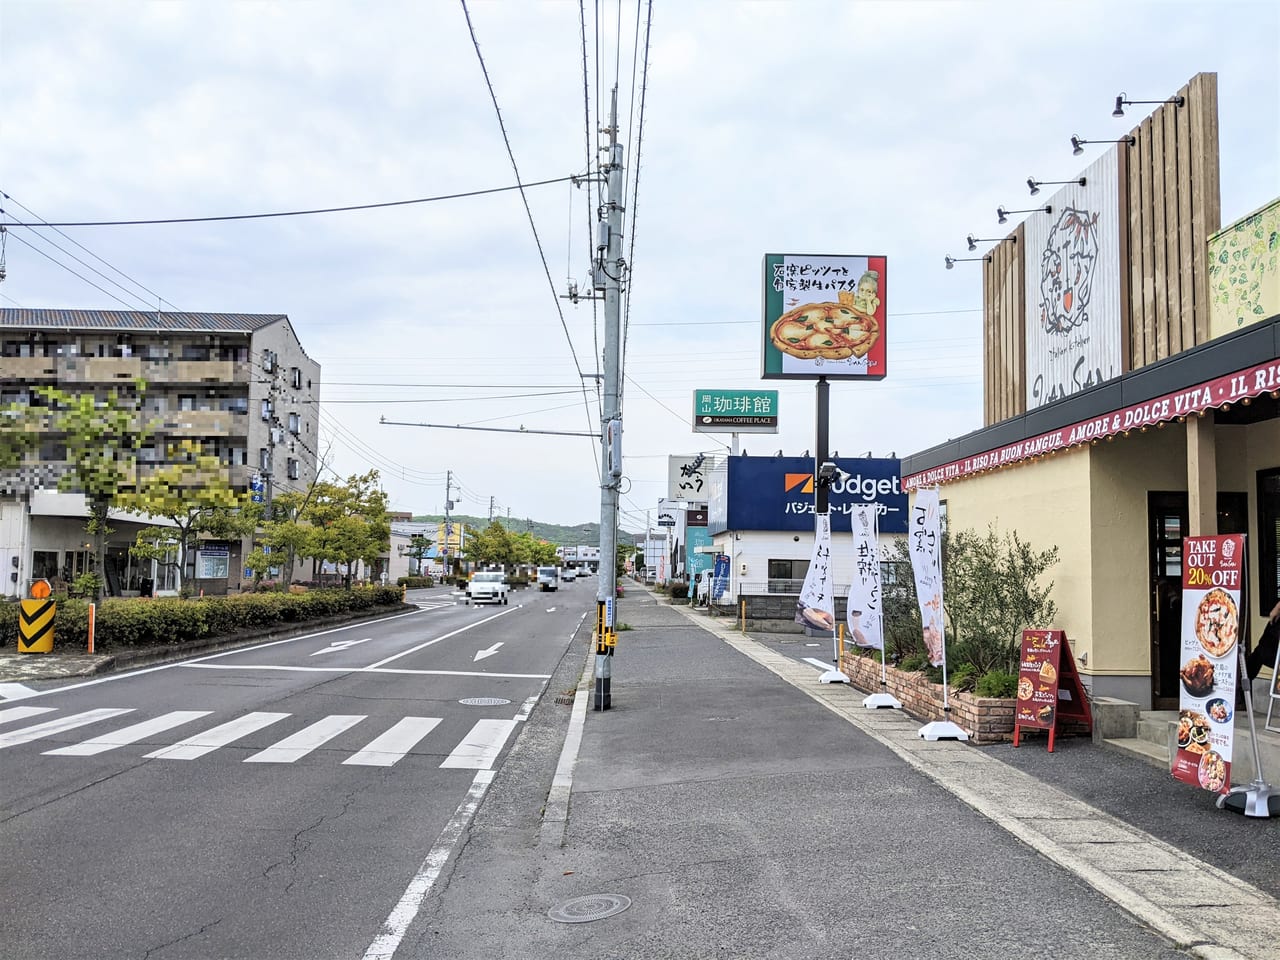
902, 73, 1280, 708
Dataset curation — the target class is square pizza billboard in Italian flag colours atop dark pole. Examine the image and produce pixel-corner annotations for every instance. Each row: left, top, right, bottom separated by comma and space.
760, 253, 888, 380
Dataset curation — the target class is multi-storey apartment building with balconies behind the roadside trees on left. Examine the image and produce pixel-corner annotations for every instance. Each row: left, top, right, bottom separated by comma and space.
0, 308, 320, 596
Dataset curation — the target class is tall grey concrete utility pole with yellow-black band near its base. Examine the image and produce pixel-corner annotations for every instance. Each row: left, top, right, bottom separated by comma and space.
593, 87, 623, 710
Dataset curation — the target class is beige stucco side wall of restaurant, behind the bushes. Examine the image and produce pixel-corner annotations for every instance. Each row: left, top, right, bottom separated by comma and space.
940, 447, 1094, 675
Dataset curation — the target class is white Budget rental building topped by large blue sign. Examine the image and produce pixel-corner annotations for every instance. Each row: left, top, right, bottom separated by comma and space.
703, 454, 908, 603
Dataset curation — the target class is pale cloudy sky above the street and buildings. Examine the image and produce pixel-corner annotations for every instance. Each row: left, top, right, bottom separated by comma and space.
0, 0, 1280, 531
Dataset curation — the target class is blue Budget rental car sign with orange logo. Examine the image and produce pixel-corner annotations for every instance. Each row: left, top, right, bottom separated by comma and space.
708, 457, 908, 535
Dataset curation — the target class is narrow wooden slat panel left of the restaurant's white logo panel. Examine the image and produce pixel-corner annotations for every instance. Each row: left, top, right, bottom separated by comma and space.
982, 224, 1027, 425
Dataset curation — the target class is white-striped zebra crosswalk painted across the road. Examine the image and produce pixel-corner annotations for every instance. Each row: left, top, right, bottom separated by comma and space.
0, 707, 518, 771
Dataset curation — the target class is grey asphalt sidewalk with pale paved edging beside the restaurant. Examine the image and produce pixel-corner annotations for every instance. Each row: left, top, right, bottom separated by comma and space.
407, 590, 1280, 960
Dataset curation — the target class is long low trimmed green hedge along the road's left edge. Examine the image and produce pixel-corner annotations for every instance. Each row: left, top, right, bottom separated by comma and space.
0, 586, 401, 650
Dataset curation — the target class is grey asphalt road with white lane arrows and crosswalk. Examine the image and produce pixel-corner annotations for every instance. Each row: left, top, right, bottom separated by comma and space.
0, 585, 594, 960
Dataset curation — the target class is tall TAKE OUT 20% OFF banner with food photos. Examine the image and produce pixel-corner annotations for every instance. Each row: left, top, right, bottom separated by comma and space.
1171, 534, 1245, 794
